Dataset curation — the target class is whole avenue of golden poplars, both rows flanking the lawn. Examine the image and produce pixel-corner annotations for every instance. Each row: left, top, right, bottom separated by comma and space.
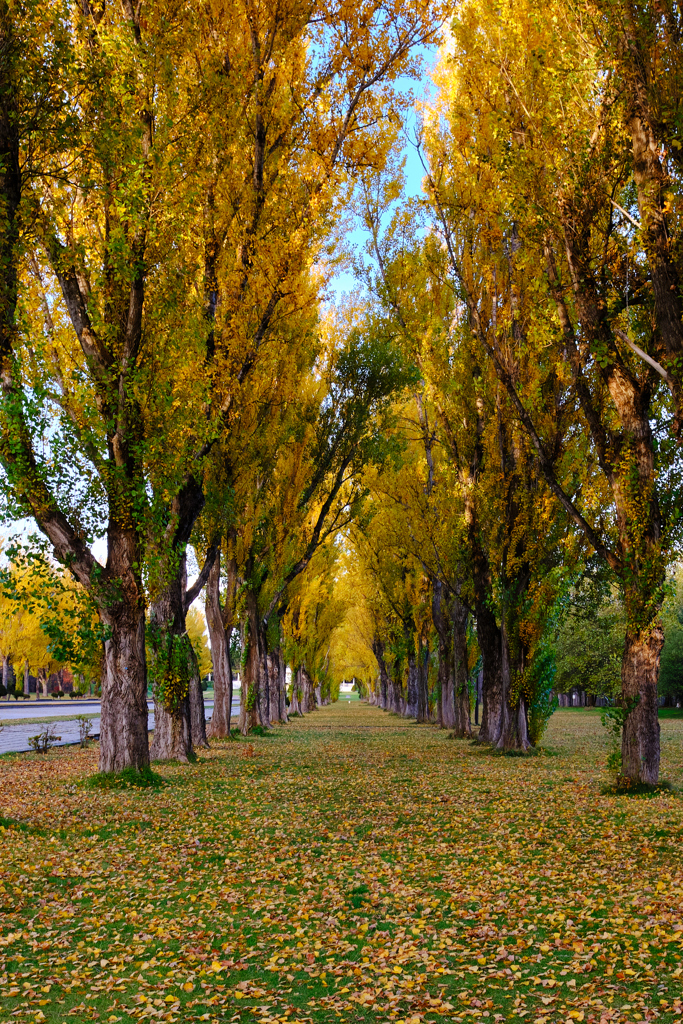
0, 0, 683, 783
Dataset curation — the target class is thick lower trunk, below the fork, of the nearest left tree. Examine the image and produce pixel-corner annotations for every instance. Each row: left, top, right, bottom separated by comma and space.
99, 601, 150, 772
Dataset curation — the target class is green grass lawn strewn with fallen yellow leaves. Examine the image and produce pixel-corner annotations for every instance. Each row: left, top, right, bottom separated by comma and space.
0, 700, 683, 1024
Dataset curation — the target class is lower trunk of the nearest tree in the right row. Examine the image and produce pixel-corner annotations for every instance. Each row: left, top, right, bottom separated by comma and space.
622, 625, 664, 785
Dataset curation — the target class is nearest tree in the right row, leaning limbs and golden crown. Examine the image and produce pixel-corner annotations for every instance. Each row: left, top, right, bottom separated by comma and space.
421, 2, 680, 784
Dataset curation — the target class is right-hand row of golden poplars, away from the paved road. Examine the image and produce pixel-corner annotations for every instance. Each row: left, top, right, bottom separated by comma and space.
311, 0, 683, 783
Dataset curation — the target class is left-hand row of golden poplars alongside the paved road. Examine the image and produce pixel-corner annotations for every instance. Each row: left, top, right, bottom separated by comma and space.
0, 0, 439, 771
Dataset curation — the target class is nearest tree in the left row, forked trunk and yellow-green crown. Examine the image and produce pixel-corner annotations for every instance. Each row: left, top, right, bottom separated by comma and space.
0, 3, 215, 771
